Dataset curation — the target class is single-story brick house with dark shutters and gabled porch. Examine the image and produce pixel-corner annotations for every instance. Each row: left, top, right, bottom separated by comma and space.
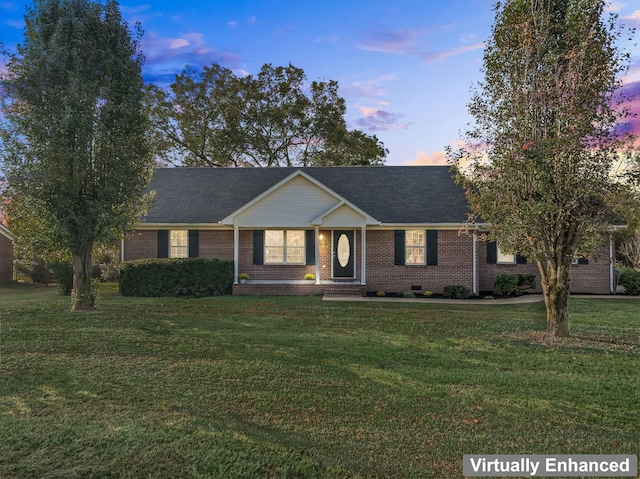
121, 166, 614, 294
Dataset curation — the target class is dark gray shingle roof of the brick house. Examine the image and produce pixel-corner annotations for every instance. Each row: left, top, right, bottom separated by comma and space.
143, 166, 468, 224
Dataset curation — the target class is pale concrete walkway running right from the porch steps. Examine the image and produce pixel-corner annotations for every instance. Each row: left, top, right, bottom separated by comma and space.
322, 294, 640, 305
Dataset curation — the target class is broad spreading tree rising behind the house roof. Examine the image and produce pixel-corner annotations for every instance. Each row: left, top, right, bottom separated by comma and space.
146, 64, 388, 167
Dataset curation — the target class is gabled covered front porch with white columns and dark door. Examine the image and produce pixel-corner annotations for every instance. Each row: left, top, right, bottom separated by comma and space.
221, 171, 379, 295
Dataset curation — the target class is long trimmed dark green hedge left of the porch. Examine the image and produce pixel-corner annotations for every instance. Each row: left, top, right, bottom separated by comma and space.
119, 258, 233, 297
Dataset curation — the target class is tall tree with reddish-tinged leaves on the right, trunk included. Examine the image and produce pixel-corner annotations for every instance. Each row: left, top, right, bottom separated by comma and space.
450, 0, 638, 337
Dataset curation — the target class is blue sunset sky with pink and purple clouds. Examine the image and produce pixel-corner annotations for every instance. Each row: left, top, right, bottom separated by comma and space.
0, 0, 640, 165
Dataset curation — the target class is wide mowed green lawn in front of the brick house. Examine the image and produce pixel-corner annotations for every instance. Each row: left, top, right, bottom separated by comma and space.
0, 285, 640, 478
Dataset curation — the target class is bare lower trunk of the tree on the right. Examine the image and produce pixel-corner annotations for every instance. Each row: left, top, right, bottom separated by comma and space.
538, 260, 571, 338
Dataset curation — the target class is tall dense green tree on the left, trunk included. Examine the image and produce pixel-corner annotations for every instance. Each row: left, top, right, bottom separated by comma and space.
1, 0, 153, 310
